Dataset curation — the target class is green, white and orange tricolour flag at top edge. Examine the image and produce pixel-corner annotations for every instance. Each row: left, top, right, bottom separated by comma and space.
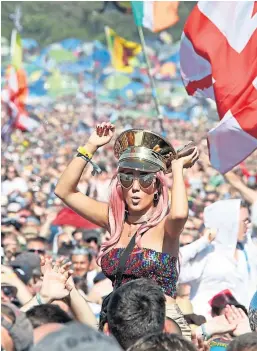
131, 1, 179, 32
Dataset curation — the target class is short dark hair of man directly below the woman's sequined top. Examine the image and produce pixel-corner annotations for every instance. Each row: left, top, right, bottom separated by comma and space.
107, 278, 165, 349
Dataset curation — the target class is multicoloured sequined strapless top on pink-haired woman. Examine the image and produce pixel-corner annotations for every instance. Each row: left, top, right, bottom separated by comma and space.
101, 247, 178, 298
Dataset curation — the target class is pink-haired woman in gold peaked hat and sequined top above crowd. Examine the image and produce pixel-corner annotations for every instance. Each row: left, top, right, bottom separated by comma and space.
55, 123, 199, 336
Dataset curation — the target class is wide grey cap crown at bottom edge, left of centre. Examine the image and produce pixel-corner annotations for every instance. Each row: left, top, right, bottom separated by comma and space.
31, 322, 122, 351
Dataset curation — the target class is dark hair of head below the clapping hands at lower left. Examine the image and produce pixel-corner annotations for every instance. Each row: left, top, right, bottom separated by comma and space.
26, 304, 72, 329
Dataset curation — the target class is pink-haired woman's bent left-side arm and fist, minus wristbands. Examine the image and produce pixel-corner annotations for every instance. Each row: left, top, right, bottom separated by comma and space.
55, 123, 115, 230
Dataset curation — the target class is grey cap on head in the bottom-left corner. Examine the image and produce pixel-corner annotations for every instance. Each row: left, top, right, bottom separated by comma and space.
1, 303, 33, 351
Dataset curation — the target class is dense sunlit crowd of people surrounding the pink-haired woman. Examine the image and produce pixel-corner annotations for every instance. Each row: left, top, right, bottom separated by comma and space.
1, 99, 257, 351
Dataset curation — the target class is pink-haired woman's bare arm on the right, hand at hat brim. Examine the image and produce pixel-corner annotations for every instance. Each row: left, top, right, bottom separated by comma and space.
165, 148, 199, 238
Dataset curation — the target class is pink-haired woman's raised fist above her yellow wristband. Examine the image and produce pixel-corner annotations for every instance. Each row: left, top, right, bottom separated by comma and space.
88, 123, 115, 148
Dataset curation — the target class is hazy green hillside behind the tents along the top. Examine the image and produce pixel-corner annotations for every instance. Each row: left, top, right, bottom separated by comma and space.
1, 1, 196, 47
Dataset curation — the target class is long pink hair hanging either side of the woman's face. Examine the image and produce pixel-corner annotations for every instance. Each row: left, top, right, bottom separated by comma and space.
97, 172, 169, 265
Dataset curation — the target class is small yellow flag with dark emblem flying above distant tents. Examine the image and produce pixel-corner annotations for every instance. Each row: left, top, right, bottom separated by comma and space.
105, 27, 142, 73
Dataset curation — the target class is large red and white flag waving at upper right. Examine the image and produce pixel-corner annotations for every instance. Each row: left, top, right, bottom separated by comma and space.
180, 1, 257, 173
